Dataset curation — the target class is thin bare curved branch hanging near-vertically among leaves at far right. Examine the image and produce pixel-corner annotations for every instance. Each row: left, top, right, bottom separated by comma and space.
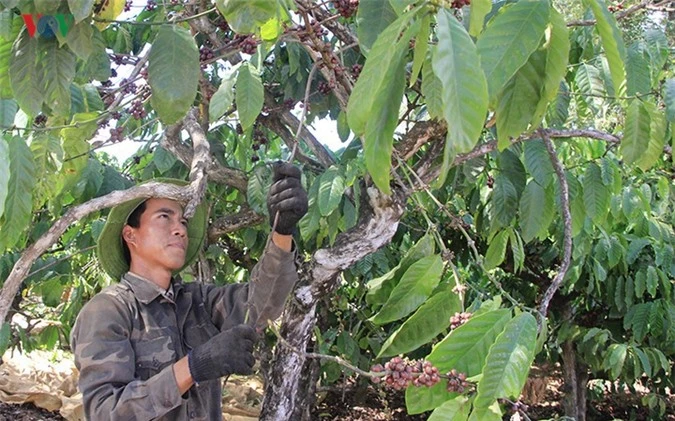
537, 130, 572, 330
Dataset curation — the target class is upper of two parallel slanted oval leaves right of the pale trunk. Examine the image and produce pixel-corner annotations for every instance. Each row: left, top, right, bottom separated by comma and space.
370, 254, 443, 325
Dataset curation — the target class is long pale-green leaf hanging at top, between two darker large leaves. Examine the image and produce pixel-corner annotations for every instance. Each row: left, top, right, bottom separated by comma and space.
432, 9, 488, 184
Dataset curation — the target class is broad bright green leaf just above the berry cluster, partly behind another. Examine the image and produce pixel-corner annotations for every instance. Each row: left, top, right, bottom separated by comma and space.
427, 309, 511, 377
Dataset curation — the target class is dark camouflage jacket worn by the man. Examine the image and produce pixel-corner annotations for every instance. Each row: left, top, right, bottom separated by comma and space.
71, 242, 297, 421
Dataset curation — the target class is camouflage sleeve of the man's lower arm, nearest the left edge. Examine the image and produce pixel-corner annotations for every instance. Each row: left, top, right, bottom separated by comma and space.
71, 294, 183, 421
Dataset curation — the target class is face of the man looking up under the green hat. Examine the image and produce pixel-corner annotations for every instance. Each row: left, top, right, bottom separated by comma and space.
122, 199, 188, 272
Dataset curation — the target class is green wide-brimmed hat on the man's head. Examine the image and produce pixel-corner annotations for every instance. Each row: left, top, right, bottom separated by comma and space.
96, 178, 207, 280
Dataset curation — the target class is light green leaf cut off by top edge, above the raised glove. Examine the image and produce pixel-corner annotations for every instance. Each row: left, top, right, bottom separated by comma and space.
216, 0, 278, 34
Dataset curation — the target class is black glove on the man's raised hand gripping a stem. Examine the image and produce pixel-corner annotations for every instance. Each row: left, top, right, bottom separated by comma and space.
267, 161, 308, 235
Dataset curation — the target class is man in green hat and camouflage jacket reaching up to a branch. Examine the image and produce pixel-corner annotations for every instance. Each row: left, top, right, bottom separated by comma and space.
71, 163, 307, 421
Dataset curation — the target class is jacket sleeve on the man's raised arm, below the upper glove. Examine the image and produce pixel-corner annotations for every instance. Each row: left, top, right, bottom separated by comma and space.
203, 241, 298, 330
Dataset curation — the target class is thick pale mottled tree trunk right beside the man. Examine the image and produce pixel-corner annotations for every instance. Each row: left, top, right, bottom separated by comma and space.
260, 188, 405, 421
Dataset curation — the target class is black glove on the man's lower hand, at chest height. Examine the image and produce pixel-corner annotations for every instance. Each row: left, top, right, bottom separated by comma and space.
188, 324, 257, 383
